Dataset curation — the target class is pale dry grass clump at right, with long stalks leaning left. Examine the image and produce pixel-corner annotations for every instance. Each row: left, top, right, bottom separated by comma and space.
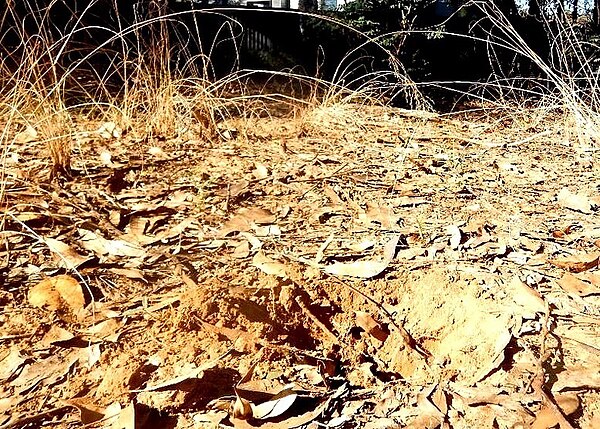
422, 1, 600, 142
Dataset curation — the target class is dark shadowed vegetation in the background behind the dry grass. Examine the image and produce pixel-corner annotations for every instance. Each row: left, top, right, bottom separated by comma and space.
0, 0, 600, 105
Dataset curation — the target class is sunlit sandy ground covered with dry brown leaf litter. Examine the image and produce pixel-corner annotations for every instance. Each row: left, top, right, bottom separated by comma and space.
0, 104, 600, 429
